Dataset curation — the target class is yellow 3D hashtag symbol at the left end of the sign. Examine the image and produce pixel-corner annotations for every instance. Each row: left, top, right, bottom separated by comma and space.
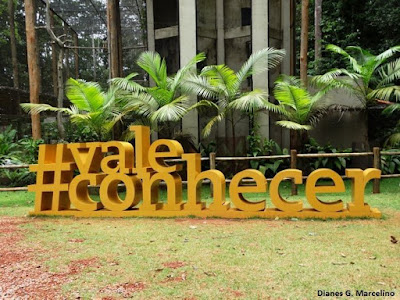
28, 144, 76, 212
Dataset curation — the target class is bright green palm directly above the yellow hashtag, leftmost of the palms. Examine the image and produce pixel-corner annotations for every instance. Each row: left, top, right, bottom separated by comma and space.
21, 78, 120, 141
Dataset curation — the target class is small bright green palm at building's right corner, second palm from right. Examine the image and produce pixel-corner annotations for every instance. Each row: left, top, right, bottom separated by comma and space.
274, 75, 332, 150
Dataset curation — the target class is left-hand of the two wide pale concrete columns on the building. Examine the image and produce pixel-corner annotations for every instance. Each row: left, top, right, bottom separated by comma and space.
179, 0, 199, 144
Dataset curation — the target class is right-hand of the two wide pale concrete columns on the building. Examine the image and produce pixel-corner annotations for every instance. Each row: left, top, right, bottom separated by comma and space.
251, 0, 269, 139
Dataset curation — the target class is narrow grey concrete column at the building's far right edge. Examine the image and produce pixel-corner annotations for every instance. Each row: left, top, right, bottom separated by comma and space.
281, 0, 292, 148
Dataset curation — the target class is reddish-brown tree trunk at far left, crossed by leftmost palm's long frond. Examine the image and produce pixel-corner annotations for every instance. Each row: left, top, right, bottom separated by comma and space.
25, 0, 41, 140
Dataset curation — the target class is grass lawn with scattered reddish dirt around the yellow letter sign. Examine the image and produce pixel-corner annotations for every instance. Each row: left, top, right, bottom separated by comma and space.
0, 179, 400, 299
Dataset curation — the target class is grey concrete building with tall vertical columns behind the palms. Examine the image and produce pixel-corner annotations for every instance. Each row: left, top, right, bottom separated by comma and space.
147, 0, 295, 154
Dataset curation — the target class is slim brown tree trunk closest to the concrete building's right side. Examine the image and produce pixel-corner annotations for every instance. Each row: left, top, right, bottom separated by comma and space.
300, 0, 310, 87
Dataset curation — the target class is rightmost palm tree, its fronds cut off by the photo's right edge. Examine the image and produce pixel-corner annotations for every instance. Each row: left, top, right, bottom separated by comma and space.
313, 45, 400, 108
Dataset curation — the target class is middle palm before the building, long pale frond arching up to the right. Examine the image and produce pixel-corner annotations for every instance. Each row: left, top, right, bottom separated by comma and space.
183, 48, 285, 153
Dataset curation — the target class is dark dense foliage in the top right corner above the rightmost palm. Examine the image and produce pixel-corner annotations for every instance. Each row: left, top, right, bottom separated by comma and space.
296, 0, 400, 75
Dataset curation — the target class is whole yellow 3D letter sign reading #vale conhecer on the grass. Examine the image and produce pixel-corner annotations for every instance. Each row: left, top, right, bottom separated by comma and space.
29, 126, 381, 218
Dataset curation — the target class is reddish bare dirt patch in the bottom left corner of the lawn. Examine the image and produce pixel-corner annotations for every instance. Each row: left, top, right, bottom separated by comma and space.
0, 217, 97, 299
